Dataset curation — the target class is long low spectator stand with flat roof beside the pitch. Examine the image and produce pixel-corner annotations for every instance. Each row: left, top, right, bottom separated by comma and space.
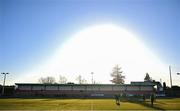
16, 82, 154, 98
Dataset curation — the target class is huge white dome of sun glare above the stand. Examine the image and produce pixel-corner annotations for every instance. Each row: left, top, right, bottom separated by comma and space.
16, 24, 168, 83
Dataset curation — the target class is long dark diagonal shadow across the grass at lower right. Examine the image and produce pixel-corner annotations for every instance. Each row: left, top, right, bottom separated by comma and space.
128, 100, 165, 110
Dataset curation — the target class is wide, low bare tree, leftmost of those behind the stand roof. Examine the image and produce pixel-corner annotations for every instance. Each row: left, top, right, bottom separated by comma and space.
39, 76, 56, 84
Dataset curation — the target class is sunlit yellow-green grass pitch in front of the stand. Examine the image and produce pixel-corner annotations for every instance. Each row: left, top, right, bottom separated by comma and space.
0, 98, 180, 110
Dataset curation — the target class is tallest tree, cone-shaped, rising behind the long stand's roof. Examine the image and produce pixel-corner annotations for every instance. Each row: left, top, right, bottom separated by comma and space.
111, 65, 125, 84
